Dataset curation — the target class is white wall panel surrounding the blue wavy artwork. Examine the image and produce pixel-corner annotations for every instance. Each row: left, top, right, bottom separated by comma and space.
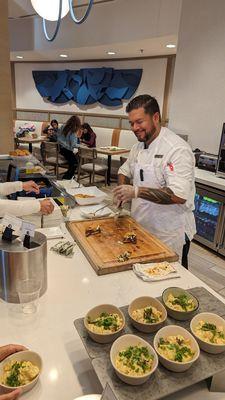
15, 58, 167, 115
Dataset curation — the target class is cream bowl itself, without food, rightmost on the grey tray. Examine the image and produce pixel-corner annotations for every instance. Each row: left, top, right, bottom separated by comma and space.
190, 312, 225, 354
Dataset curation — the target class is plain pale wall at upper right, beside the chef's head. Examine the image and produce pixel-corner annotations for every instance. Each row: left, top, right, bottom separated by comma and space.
169, 0, 225, 154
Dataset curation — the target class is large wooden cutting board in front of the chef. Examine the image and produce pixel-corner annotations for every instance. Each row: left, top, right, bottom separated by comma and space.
67, 216, 178, 275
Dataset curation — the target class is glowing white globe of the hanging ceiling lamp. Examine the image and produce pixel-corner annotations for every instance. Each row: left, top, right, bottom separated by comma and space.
31, 0, 69, 21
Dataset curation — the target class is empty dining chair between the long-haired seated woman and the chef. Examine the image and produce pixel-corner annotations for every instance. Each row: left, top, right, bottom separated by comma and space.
77, 146, 108, 186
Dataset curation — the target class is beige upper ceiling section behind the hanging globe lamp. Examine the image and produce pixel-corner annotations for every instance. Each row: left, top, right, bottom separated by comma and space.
9, 0, 181, 51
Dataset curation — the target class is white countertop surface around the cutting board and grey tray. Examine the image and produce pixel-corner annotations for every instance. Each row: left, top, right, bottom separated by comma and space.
0, 207, 225, 400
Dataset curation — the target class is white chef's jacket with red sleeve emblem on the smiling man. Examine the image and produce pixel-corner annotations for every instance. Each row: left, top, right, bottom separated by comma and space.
118, 127, 196, 240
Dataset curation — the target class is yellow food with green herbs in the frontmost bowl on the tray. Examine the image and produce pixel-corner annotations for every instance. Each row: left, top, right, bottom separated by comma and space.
116, 345, 154, 376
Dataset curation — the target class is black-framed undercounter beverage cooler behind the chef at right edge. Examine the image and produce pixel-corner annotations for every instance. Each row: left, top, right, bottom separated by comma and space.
194, 184, 225, 255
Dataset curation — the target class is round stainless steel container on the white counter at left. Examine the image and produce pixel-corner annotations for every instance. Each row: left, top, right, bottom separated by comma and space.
0, 232, 47, 303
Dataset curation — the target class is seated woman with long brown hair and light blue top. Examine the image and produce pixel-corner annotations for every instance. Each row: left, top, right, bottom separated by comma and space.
57, 115, 81, 179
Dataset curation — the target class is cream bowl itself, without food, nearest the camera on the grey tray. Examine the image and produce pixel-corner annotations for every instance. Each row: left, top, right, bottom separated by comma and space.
110, 334, 158, 385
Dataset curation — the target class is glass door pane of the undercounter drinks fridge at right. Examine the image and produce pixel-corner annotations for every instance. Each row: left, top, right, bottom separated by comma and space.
194, 193, 223, 249
